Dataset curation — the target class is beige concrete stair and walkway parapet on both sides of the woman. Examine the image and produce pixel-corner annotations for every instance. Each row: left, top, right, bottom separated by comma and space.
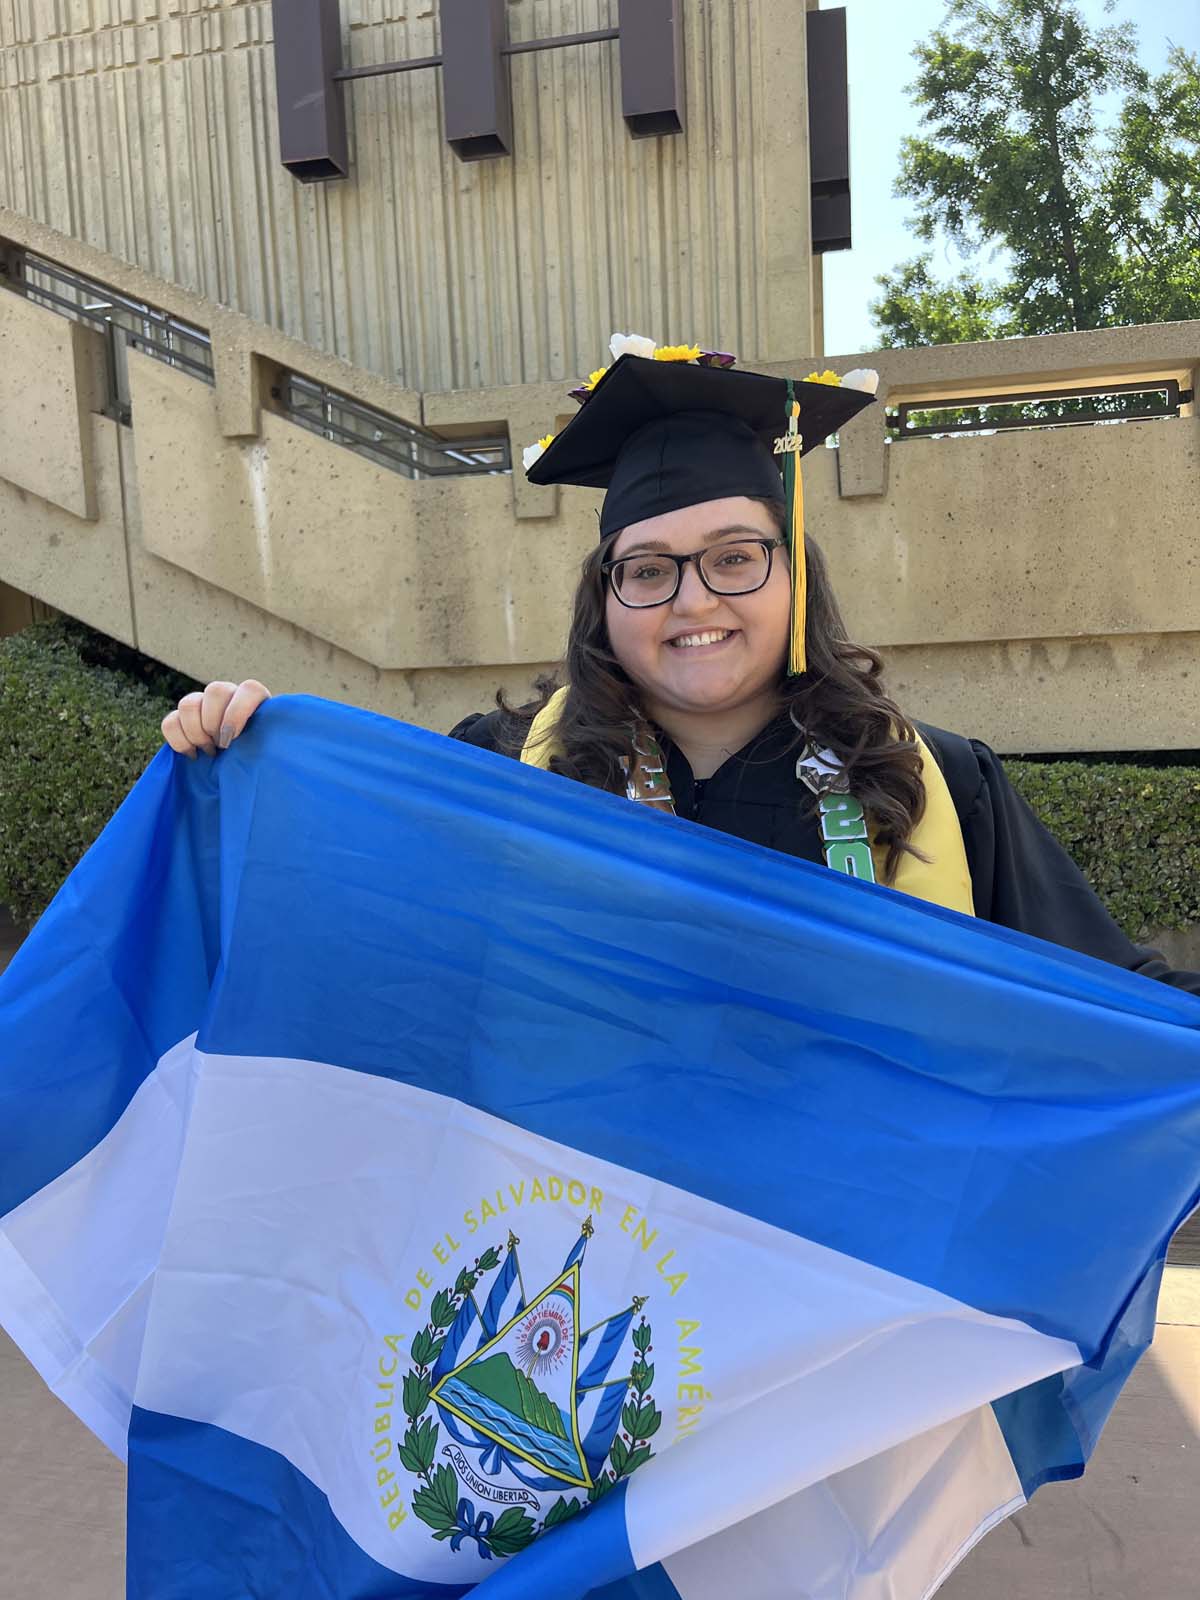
0, 210, 1200, 750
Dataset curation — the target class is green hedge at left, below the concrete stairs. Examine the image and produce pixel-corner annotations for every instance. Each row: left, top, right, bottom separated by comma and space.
0, 619, 195, 922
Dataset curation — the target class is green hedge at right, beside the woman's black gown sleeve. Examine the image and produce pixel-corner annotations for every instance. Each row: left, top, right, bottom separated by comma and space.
1005, 760, 1200, 939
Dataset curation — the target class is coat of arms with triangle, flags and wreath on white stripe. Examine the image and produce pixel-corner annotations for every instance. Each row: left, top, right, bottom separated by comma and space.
385, 1216, 662, 1560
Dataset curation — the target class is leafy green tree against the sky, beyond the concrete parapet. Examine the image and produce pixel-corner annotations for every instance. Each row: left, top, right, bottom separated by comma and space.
872, 0, 1200, 344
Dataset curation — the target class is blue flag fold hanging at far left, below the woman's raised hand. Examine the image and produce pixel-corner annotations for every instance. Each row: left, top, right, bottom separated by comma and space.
0, 749, 219, 1216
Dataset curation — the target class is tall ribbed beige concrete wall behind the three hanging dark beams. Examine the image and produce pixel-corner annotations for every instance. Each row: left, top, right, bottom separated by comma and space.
0, 0, 813, 389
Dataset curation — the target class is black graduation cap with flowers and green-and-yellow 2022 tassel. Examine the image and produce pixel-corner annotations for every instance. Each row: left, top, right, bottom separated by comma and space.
526, 341, 875, 674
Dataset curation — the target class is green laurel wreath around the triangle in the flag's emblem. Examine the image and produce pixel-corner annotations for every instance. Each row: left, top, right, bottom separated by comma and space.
397, 1245, 662, 1557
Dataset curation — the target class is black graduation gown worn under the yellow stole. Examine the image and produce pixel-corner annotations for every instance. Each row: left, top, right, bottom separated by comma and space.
451, 712, 1200, 995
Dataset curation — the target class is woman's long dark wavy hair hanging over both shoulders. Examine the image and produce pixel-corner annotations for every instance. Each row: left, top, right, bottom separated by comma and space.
499, 501, 925, 882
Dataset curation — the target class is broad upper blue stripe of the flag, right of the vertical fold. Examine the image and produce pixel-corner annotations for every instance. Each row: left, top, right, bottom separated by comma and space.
185, 699, 1200, 1357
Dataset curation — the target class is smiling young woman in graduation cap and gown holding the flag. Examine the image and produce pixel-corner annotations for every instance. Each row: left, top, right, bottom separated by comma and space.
163, 349, 1200, 994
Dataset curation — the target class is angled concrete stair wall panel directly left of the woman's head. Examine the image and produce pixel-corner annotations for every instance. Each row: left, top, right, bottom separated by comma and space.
130, 354, 595, 670
